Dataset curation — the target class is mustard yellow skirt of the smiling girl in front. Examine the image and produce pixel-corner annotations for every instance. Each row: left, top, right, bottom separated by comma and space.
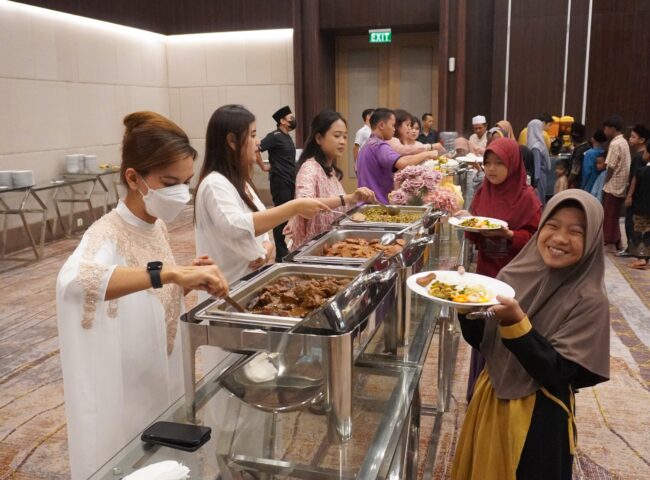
451, 369, 536, 480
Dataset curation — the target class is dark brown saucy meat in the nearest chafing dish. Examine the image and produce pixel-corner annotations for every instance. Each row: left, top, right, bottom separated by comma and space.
247, 275, 350, 318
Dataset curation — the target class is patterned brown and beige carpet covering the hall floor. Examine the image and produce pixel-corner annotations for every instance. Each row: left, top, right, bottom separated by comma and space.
0, 215, 650, 480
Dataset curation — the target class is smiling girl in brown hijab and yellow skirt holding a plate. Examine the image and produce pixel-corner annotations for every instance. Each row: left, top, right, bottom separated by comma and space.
452, 189, 609, 480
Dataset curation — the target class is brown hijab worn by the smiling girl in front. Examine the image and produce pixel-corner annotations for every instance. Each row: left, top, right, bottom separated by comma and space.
481, 189, 610, 400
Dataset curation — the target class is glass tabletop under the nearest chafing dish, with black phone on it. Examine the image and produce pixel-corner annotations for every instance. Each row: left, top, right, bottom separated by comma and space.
91, 365, 420, 480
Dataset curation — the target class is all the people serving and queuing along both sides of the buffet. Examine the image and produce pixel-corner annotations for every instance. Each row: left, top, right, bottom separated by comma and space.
57, 105, 650, 479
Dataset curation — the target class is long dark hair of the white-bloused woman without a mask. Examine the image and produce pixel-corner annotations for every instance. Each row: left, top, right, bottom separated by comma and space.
195, 105, 258, 212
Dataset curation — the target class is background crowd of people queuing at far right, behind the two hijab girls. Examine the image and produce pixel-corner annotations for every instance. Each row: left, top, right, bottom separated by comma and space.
450, 114, 650, 269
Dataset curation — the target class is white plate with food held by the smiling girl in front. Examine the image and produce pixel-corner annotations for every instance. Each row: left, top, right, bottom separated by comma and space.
406, 270, 515, 307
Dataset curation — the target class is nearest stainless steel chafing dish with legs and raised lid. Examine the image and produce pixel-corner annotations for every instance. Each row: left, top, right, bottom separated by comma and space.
181, 257, 397, 441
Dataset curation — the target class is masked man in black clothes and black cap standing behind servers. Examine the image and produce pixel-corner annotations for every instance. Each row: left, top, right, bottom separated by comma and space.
258, 105, 296, 262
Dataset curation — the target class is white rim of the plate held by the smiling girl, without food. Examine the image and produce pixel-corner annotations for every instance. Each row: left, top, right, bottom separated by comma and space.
406, 270, 515, 307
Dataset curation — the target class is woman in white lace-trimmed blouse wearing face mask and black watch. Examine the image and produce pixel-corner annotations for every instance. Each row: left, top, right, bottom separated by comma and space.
56, 112, 228, 479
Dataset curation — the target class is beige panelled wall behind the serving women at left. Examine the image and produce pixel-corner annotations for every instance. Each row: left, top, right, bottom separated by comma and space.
0, 2, 293, 236
